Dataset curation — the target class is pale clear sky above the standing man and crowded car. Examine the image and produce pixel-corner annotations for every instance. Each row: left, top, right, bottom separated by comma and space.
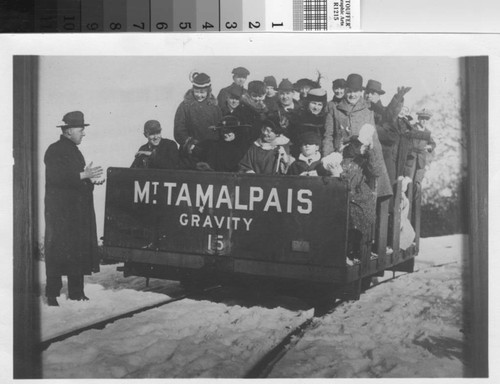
37, 54, 459, 237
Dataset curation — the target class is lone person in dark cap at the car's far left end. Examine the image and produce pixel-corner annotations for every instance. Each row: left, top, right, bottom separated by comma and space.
131, 120, 179, 169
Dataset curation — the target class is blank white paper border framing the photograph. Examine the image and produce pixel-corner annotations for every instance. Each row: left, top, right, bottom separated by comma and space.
0, 33, 500, 380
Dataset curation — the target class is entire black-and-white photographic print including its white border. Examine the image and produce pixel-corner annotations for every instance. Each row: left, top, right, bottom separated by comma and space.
2, 34, 499, 379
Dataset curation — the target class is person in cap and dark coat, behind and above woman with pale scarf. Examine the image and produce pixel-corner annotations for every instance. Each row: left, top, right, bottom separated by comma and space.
234, 80, 268, 146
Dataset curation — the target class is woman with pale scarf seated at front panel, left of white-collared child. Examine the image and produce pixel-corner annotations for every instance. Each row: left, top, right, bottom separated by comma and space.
240, 120, 293, 175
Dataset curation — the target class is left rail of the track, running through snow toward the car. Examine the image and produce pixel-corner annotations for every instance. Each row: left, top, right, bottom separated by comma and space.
38, 286, 224, 352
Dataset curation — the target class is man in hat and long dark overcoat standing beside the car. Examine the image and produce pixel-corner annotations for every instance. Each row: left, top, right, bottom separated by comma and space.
44, 111, 102, 306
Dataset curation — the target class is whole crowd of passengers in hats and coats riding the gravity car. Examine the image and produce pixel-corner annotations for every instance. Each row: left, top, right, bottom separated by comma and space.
132, 67, 436, 262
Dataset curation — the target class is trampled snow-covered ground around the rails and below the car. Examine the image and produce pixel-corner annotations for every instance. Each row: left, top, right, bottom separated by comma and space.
40, 235, 467, 378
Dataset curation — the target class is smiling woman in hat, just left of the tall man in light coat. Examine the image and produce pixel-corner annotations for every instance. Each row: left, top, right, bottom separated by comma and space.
289, 88, 326, 157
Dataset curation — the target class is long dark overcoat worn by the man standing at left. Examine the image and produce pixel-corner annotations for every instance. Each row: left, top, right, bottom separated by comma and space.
44, 136, 99, 276
